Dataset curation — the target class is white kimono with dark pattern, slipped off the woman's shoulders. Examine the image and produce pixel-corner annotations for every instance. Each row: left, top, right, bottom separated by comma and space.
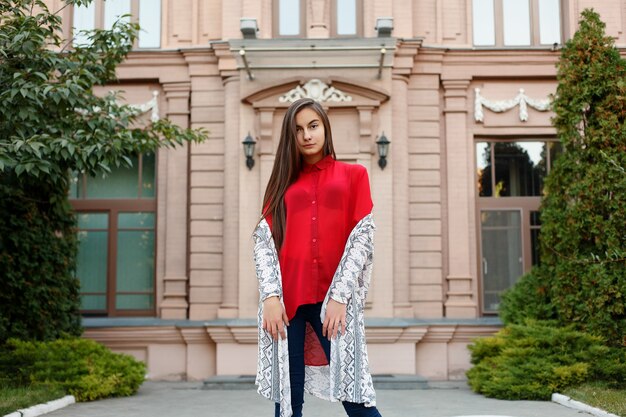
253, 214, 376, 417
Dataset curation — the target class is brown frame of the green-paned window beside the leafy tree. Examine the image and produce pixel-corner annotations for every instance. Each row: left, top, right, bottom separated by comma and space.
69, 152, 158, 317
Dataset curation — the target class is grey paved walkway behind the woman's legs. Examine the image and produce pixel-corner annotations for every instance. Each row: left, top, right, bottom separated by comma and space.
46, 382, 589, 417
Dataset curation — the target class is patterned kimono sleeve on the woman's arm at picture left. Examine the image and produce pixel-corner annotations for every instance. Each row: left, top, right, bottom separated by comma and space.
254, 220, 282, 301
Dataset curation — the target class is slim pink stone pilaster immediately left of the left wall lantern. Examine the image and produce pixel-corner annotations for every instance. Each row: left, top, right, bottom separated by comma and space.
218, 75, 243, 318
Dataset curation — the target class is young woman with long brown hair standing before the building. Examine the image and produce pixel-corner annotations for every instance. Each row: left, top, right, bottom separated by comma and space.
254, 99, 380, 417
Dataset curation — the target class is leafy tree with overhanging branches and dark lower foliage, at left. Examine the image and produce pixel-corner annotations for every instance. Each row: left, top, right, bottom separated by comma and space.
0, 0, 205, 341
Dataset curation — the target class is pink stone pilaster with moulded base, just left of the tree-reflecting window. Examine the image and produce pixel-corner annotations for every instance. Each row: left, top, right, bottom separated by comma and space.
442, 79, 478, 318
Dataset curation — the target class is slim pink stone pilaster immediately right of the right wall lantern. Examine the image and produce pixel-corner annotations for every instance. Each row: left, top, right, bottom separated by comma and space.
390, 73, 413, 317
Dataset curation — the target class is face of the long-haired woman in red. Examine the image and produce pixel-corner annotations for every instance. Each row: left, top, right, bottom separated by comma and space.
296, 107, 326, 164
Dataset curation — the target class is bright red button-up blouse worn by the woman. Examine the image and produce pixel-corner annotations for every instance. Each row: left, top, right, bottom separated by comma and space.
267, 155, 373, 319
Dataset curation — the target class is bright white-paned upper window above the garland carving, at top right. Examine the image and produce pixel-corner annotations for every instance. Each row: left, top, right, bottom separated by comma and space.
472, 0, 561, 47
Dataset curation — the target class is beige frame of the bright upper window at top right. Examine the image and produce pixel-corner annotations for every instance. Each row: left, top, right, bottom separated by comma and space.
471, 0, 565, 49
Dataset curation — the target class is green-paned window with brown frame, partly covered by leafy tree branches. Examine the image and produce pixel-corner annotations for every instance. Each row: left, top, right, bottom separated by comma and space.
70, 154, 156, 317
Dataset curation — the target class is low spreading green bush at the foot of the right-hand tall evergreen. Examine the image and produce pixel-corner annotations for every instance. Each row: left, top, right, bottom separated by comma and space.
467, 321, 626, 400
